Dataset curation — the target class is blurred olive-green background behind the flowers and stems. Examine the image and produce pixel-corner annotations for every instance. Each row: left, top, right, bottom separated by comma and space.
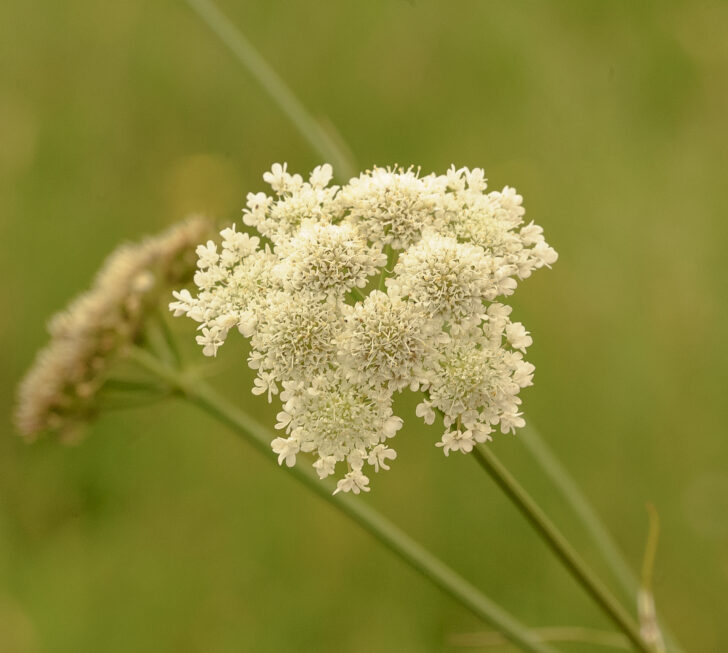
0, 0, 728, 653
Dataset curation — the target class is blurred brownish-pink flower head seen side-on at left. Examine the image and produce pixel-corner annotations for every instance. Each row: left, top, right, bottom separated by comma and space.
15, 217, 212, 439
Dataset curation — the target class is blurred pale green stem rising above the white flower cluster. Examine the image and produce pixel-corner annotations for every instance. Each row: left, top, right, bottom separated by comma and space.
185, 0, 356, 180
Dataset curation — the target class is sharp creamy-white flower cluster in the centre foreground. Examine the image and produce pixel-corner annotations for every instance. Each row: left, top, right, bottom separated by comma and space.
170, 164, 557, 494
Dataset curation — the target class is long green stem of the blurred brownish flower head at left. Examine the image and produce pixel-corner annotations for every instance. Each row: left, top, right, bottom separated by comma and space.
129, 348, 556, 653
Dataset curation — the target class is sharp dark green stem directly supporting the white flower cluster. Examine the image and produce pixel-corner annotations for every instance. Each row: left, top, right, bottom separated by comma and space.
473, 445, 654, 653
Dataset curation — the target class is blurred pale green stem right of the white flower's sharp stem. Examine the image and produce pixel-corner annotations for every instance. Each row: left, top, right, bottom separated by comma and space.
518, 425, 684, 653
